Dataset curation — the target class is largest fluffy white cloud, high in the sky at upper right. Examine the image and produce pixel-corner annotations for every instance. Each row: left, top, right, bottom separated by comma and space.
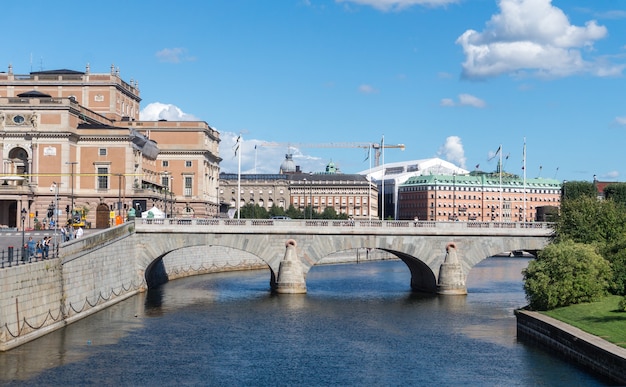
456, 0, 624, 79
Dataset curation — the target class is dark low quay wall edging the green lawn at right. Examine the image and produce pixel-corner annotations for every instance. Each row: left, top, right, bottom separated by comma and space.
515, 310, 626, 385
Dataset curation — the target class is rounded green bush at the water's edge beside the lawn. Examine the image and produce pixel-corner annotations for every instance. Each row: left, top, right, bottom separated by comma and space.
522, 241, 611, 310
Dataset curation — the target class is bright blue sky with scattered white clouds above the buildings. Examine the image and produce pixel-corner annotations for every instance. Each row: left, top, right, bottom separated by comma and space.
0, 0, 626, 181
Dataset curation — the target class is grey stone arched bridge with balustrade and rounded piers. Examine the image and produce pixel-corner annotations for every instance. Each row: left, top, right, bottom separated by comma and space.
135, 219, 552, 294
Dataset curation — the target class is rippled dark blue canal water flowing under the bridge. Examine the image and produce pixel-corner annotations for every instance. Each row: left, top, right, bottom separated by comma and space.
0, 258, 603, 386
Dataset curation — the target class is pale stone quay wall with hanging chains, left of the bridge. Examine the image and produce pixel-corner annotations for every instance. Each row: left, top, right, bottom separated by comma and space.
0, 224, 144, 351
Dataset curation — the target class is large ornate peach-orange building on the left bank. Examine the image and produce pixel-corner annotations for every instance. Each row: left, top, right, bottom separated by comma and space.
0, 66, 221, 228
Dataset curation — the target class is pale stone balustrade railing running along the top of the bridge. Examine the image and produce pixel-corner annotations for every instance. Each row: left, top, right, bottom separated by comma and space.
135, 218, 554, 230
